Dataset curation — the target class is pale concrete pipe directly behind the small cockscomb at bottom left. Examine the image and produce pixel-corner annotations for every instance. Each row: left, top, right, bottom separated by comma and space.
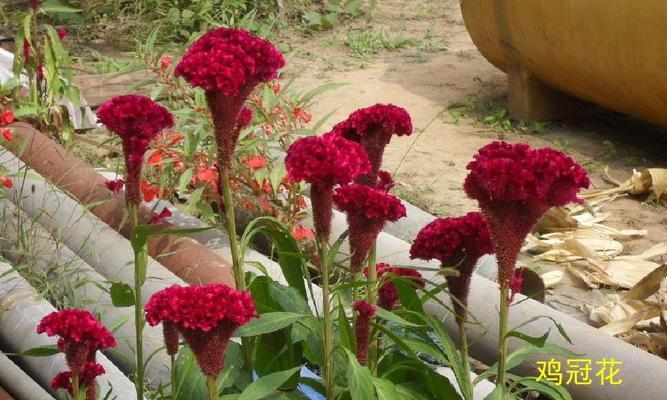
0, 263, 136, 399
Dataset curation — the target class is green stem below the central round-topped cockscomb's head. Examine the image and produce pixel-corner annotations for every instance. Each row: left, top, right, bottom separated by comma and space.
317, 243, 335, 399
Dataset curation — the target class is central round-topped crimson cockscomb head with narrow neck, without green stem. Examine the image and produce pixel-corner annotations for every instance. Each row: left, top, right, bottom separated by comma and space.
285, 134, 370, 242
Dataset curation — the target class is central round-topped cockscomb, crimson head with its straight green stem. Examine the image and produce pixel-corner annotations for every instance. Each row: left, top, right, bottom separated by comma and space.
285, 134, 370, 399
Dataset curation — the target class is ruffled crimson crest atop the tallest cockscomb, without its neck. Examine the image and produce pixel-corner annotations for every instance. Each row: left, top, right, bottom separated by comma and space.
175, 28, 285, 96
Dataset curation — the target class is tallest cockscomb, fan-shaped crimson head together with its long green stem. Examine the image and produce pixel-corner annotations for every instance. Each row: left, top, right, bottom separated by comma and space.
174, 28, 285, 371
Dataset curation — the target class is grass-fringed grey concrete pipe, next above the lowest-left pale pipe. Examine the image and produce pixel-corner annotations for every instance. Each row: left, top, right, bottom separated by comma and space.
0, 199, 171, 387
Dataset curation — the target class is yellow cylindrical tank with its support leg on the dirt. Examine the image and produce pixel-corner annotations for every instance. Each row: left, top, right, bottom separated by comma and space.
461, 0, 667, 125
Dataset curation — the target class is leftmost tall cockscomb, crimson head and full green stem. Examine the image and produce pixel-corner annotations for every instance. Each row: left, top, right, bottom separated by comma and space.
97, 95, 174, 399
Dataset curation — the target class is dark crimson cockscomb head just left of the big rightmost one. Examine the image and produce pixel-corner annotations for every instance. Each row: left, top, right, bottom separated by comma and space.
410, 212, 492, 323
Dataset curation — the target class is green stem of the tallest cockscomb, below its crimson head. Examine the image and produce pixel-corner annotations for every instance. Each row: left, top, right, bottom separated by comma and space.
218, 163, 253, 372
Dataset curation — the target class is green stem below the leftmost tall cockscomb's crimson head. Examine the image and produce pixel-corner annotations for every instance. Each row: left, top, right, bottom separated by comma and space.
129, 205, 148, 400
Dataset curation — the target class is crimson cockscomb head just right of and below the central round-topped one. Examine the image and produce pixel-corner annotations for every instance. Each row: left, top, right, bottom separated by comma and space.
333, 183, 406, 273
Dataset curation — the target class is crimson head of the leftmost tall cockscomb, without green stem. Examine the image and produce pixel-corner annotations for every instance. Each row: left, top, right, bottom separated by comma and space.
97, 95, 174, 205
